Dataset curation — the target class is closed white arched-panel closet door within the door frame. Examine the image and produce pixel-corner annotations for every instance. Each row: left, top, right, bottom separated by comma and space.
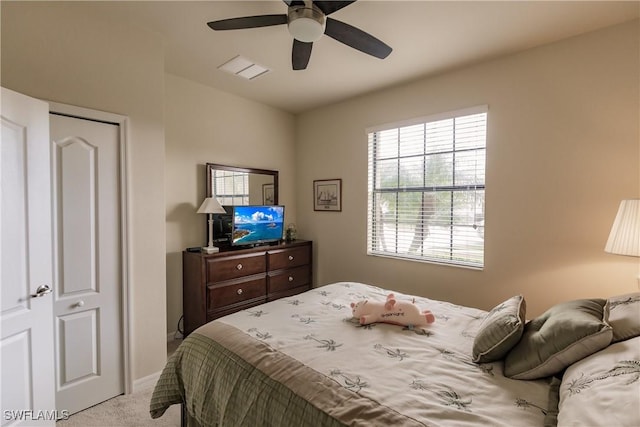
50, 114, 124, 413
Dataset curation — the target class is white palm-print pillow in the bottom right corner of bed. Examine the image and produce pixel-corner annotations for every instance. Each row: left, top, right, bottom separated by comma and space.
558, 337, 640, 427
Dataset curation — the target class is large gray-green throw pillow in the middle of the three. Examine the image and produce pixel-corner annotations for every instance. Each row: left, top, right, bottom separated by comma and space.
504, 299, 613, 380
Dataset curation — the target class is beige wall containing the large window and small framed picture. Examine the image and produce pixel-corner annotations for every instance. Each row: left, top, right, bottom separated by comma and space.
296, 21, 640, 315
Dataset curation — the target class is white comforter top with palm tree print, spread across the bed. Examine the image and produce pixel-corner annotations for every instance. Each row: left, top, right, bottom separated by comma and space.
216, 282, 549, 426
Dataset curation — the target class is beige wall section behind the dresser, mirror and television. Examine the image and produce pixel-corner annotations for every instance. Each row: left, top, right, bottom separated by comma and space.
165, 75, 296, 332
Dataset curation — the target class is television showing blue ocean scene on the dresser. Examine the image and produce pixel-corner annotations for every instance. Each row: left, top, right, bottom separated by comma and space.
231, 206, 284, 246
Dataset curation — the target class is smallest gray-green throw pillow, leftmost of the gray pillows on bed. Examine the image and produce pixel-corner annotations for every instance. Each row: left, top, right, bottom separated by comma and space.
473, 295, 527, 363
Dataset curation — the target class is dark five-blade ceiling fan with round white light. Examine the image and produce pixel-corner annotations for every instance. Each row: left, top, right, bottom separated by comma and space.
207, 0, 392, 70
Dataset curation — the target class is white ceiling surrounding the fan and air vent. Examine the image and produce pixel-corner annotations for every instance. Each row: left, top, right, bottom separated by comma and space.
92, 0, 640, 113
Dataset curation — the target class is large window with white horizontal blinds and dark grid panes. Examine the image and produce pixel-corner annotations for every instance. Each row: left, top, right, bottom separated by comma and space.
367, 106, 487, 268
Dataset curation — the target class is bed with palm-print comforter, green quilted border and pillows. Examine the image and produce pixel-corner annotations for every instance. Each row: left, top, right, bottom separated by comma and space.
150, 282, 640, 426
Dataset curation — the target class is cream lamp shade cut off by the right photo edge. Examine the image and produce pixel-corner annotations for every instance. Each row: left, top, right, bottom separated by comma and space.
604, 199, 640, 256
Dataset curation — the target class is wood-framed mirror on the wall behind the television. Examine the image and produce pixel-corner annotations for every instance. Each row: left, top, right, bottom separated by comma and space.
206, 163, 278, 206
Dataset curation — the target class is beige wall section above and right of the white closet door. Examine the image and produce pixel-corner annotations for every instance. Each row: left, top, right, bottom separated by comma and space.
1, 2, 166, 379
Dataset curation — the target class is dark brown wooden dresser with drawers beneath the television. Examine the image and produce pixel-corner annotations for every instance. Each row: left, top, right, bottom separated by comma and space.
182, 240, 312, 336
